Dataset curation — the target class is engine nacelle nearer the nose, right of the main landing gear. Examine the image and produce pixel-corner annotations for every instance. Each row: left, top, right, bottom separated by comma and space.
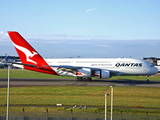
94, 70, 110, 78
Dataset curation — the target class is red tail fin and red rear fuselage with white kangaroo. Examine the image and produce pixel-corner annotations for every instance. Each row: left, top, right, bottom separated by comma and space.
8, 31, 57, 74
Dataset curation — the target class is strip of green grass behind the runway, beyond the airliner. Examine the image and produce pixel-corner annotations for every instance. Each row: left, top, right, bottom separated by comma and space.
0, 69, 160, 81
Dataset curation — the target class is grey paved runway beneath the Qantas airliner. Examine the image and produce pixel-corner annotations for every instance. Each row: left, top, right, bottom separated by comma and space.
0, 78, 160, 88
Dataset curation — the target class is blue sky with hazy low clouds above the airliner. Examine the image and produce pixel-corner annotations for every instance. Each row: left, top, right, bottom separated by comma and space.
0, 0, 160, 58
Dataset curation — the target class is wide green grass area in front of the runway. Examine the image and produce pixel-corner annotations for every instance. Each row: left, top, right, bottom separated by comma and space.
0, 86, 160, 114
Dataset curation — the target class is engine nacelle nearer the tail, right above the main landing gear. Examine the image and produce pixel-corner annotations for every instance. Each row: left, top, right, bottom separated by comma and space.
77, 68, 91, 77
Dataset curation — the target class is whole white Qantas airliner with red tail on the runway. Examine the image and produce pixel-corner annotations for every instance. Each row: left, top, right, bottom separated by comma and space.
8, 31, 158, 81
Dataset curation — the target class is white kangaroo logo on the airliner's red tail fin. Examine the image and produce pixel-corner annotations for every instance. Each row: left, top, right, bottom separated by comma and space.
13, 43, 38, 64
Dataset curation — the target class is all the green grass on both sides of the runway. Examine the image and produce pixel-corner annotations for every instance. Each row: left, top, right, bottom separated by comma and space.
0, 70, 160, 114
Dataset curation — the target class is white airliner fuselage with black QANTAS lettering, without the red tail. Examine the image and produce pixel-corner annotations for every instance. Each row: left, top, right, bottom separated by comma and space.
45, 58, 158, 75
